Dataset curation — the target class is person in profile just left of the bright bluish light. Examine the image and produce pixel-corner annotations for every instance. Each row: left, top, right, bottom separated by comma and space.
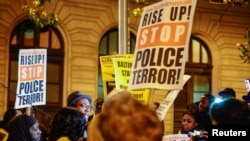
198, 94, 215, 131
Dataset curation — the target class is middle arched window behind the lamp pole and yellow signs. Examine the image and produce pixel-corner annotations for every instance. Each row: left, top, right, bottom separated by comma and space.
98, 28, 136, 97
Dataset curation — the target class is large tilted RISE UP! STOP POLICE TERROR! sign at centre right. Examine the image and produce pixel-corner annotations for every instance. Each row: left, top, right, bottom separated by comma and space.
128, 0, 196, 90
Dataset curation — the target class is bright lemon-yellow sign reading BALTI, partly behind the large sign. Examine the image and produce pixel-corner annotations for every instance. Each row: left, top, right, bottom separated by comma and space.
112, 58, 149, 104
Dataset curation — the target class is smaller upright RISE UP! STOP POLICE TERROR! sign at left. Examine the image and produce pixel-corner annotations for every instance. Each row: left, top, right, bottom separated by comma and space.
15, 49, 47, 109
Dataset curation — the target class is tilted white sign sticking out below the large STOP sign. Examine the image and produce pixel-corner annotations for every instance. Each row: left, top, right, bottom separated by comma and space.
156, 75, 191, 121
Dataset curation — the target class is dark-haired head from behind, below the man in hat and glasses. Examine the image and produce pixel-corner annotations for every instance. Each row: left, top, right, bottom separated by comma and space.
49, 107, 86, 141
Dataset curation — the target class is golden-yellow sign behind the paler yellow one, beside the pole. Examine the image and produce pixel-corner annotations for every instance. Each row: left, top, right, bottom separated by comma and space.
100, 54, 133, 97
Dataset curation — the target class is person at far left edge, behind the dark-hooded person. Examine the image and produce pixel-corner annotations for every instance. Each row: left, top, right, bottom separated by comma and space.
0, 108, 24, 128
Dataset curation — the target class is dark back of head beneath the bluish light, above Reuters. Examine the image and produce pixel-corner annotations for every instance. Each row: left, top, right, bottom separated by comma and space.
209, 98, 250, 126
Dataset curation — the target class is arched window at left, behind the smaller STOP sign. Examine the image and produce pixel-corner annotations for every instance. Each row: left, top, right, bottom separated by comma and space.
8, 19, 64, 121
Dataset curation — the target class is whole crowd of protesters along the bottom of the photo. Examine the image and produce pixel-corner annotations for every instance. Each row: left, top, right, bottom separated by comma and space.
0, 88, 250, 141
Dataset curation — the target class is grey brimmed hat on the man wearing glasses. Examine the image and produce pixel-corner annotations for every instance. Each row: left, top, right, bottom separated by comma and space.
67, 91, 92, 106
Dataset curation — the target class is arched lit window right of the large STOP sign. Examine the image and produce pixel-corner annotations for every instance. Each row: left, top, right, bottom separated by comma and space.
185, 36, 213, 102
